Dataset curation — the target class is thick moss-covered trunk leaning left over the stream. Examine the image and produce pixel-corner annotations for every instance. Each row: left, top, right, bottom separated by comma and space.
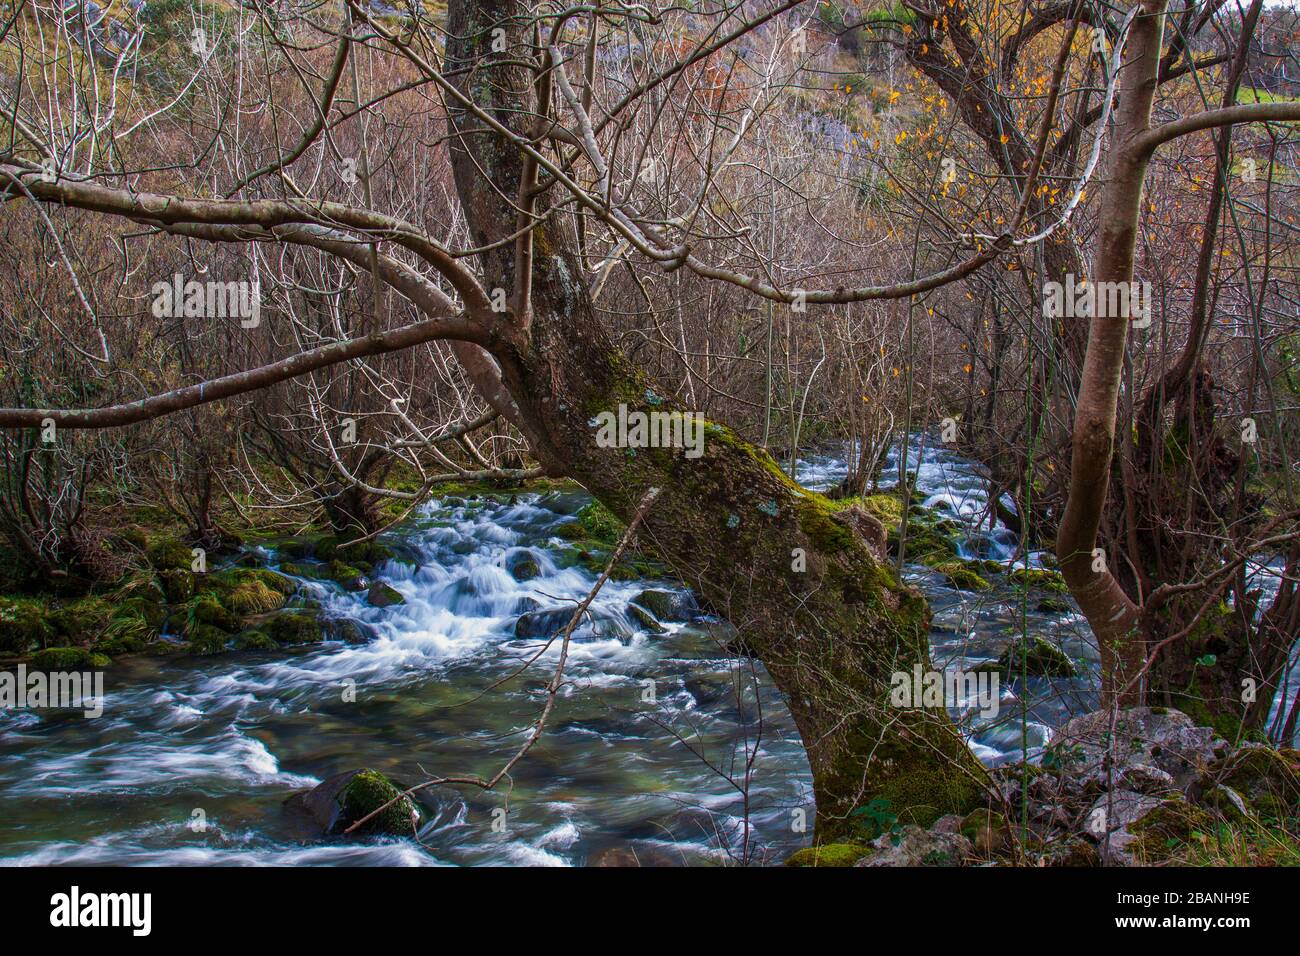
446, 0, 983, 840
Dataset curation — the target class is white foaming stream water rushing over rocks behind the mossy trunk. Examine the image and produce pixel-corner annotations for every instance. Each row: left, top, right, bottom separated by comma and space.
0, 445, 1289, 865
